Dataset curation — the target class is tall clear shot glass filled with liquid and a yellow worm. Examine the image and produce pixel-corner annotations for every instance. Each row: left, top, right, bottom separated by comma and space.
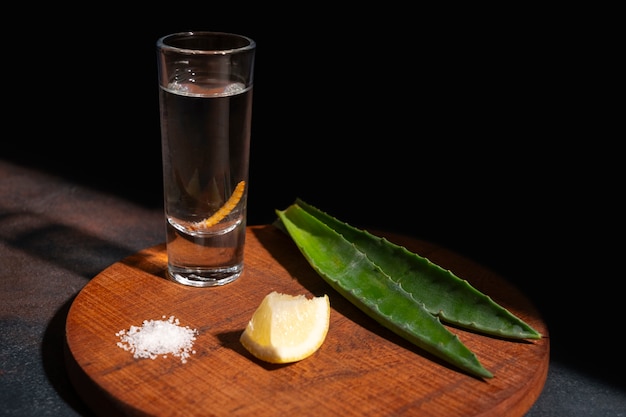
157, 31, 256, 287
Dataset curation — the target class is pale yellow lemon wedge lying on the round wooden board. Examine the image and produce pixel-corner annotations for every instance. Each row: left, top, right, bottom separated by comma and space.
240, 291, 330, 363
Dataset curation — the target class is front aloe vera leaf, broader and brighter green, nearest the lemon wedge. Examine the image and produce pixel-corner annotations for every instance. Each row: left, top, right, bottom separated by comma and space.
276, 204, 493, 378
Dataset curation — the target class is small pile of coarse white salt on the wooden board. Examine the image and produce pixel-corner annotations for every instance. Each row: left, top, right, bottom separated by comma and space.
115, 316, 198, 363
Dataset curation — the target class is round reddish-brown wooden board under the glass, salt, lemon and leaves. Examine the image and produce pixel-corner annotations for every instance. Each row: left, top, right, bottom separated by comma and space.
66, 225, 549, 417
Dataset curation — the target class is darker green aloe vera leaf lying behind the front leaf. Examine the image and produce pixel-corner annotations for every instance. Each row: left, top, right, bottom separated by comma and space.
296, 199, 541, 339
